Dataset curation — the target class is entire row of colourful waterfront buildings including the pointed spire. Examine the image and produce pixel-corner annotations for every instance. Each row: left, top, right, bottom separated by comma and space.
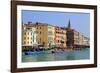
22, 21, 89, 48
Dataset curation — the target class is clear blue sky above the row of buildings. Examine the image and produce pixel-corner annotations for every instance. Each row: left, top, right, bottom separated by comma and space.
22, 10, 90, 37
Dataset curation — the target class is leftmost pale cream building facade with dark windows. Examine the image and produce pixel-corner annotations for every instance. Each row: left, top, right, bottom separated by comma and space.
22, 27, 37, 48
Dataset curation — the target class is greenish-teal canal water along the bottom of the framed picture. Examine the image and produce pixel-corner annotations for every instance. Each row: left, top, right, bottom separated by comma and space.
22, 48, 90, 62
